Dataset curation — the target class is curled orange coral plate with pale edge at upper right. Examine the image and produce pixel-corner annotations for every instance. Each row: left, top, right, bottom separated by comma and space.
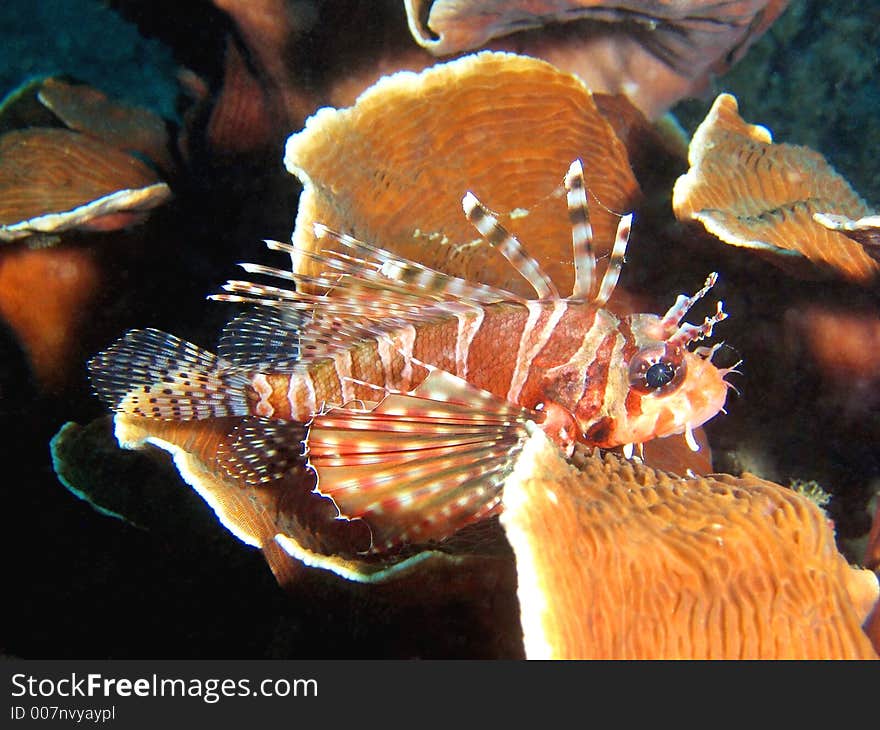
672, 94, 880, 283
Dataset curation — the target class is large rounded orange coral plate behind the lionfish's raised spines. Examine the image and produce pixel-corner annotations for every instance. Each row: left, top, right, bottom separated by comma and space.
285, 53, 640, 295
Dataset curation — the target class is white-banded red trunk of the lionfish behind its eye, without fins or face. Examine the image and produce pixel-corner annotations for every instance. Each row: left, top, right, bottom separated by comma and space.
252, 299, 624, 421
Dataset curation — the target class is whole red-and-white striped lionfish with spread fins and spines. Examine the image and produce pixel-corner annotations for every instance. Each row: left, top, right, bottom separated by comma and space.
89, 160, 731, 554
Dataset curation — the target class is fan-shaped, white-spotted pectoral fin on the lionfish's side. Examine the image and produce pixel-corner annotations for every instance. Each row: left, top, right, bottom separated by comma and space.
306, 370, 538, 550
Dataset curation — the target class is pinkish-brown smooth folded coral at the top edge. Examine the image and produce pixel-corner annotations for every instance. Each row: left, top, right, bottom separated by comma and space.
404, 0, 788, 117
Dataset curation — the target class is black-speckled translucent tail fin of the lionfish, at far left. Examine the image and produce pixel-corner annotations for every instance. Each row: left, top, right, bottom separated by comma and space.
89, 329, 249, 421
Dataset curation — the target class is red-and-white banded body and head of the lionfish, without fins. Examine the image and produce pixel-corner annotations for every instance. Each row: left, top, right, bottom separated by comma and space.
237, 292, 727, 447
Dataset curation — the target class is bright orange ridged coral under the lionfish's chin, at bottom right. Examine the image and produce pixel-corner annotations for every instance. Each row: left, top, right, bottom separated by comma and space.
501, 433, 878, 659
